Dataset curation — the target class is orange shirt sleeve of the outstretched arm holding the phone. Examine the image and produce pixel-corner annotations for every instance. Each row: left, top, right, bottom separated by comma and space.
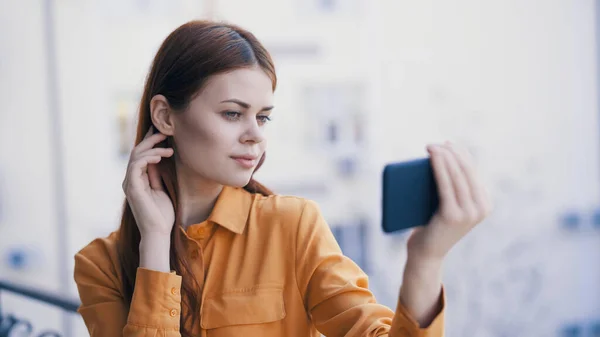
295, 200, 445, 337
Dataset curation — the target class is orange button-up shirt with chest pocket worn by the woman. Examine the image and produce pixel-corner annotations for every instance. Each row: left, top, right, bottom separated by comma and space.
75, 187, 444, 337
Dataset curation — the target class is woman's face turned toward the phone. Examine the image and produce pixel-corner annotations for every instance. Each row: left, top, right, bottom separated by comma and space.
172, 67, 273, 187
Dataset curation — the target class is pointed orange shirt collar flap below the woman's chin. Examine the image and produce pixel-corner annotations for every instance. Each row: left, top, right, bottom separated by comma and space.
208, 186, 255, 234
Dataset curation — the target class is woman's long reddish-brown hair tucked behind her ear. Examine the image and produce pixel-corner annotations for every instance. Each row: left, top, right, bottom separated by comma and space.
118, 20, 277, 337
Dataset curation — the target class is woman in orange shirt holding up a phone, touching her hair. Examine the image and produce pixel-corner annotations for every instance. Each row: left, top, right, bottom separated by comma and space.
75, 21, 490, 337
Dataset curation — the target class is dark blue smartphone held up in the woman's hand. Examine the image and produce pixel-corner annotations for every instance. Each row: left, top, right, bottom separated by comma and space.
382, 157, 439, 233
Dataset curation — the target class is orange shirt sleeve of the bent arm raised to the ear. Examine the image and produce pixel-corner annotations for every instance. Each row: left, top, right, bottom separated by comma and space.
74, 243, 181, 337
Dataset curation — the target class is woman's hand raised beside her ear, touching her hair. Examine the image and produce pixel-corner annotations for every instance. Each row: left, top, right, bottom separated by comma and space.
122, 127, 175, 238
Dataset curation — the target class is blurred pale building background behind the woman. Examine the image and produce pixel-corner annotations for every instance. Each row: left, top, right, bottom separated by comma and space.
0, 0, 600, 337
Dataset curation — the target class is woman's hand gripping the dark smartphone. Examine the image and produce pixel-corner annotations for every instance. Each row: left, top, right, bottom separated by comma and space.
407, 142, 492, 263
